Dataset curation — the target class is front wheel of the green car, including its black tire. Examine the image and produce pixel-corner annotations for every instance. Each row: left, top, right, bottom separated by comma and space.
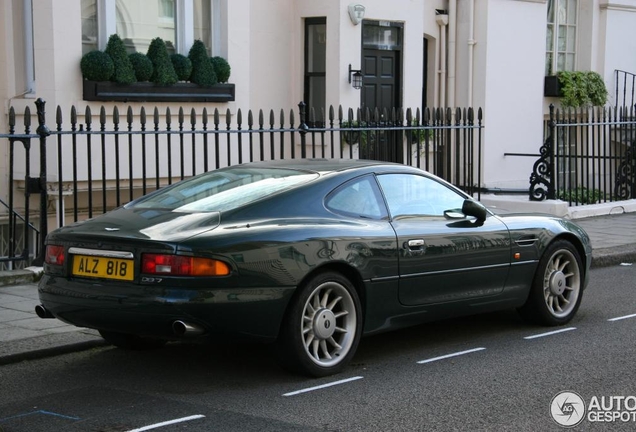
519, 240, 584, 326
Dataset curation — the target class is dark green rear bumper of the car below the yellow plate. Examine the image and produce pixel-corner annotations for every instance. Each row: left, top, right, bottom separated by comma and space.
38, 275, 295, 342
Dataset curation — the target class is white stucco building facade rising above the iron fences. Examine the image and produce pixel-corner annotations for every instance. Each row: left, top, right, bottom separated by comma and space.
0, 0, 636, 202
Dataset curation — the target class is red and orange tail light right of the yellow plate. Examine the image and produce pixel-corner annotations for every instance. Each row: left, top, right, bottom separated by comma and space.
141, 254, 230, 276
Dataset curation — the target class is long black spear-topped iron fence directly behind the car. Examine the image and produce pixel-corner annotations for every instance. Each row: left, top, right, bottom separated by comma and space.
0, 100, 483, 270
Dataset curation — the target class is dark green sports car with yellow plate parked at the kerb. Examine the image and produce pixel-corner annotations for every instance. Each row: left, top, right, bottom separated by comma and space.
36, 160, 591, 376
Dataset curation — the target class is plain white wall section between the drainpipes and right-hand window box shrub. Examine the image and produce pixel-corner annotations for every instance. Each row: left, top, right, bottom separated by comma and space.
474, 0, 547, 188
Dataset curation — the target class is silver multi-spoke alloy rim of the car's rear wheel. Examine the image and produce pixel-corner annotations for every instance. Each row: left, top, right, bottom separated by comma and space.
301, 281, 357, 367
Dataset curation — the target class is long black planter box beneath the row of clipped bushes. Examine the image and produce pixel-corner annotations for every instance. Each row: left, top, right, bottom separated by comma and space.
83, 80, 235, 102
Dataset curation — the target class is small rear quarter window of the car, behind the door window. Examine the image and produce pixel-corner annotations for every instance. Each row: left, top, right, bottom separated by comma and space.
325, 176, 387, 219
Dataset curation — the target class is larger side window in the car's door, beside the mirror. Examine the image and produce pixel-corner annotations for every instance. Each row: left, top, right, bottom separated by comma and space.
378, 174, 465, 218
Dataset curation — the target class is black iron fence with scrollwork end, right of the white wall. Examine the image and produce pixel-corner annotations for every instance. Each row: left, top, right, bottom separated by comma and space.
530, 105, 636, 206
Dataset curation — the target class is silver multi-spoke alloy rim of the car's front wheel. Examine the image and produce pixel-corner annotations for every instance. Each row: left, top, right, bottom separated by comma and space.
543, 249, 581, 318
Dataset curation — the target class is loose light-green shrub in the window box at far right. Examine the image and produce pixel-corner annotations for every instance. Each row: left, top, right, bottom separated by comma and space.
557, 71, 607, 108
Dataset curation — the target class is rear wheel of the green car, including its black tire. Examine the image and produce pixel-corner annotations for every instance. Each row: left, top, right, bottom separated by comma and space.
277, 272, 362, 377
